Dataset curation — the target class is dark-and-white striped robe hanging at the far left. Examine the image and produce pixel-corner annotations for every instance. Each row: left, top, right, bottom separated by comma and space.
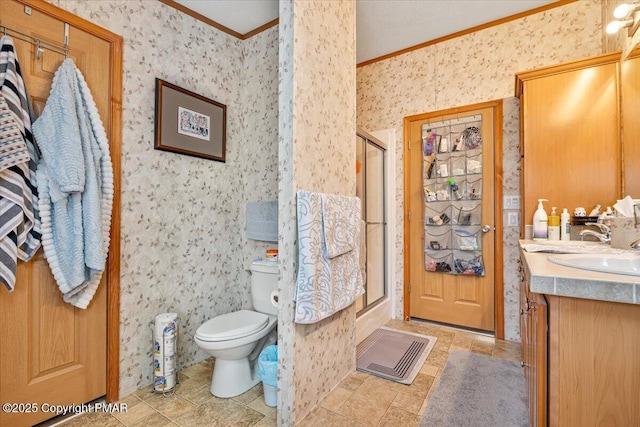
0, 36, 41, 291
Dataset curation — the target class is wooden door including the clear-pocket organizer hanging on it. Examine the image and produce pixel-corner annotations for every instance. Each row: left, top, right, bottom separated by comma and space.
404, 101, 503, 337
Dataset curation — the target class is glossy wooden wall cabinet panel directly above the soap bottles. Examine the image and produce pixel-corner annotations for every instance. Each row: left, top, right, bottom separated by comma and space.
516, 52, 621, 224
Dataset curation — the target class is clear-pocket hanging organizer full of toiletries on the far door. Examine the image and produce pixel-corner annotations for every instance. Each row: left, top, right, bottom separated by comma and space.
422, 115, 485, 276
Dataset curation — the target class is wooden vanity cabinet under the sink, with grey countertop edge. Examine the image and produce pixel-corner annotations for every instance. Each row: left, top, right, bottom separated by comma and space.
520, 254, 640, 427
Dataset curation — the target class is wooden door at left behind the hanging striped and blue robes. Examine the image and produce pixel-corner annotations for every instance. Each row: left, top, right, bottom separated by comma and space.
0, 0, 113, 426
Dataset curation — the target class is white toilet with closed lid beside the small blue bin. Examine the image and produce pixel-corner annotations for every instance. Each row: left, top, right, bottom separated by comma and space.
195, 260, 278, 397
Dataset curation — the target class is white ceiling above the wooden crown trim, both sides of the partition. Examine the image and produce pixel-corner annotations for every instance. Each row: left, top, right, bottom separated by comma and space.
176, 0, 555, 63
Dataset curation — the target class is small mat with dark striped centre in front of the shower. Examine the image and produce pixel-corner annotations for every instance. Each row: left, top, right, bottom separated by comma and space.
356, 326, 436, 384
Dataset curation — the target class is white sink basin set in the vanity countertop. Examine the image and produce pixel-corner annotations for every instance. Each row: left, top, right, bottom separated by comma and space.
549, 254, 640, 276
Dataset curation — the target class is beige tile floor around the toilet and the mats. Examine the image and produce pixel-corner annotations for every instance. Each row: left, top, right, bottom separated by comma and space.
61, 320, 521, 427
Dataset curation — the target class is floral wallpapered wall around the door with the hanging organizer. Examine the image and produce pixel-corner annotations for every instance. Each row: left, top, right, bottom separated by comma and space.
357, 1, 603, 340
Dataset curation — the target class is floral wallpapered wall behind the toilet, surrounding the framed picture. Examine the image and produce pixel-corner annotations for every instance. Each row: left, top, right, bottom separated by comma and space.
51, 0, 278, 396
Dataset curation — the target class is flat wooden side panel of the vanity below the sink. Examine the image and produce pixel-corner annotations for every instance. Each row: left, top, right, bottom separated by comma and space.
547, 295, 640, 427
